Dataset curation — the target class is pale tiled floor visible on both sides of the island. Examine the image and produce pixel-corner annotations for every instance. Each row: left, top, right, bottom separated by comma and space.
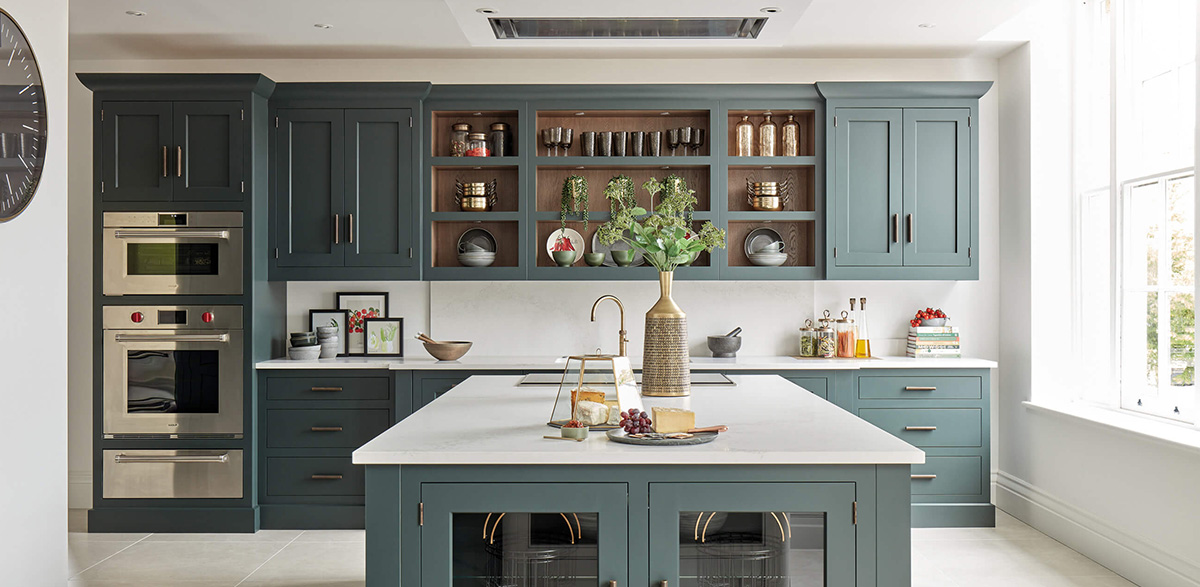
71, 511, 1133, 587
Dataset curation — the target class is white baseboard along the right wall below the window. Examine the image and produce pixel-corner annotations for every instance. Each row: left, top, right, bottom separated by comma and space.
996, 471, 1200, 587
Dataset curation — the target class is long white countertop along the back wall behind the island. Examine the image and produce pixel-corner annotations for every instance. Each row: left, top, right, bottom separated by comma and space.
256, 354, 996, 371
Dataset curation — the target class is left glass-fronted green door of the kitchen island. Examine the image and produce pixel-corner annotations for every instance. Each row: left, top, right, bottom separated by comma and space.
421, 483, 630, 587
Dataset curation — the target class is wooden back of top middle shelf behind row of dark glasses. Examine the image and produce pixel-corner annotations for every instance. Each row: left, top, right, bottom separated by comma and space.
534, 110, 712, 156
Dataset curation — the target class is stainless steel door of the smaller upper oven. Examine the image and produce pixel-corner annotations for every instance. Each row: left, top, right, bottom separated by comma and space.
103, 228, 242, 295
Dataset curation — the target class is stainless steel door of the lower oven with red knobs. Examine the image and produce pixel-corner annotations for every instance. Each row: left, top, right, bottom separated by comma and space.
104, 330, 242, 436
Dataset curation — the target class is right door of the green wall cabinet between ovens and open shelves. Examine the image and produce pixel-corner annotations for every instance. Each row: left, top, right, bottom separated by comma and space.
346, 108, 418, 266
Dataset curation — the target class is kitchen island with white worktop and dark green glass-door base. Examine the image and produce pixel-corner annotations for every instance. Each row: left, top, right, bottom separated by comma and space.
354, 376, 924, 587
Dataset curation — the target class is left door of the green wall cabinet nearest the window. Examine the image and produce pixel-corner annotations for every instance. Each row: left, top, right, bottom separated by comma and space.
832, 108, 904, 266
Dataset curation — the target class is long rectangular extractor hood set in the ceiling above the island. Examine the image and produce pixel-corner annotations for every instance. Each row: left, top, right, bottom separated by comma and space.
487, 17, 768, 40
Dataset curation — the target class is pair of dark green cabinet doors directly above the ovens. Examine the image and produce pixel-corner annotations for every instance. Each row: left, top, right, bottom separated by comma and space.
100, 101, 246, 203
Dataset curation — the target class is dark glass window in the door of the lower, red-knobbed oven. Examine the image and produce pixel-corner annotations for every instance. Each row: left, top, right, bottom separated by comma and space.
127, 351, 221, 414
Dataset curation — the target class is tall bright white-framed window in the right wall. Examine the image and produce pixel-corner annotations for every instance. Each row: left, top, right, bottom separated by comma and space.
1074, 0, 1200, 423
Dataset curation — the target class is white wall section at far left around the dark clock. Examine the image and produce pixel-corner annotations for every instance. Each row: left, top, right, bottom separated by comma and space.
0, 0, 68, 586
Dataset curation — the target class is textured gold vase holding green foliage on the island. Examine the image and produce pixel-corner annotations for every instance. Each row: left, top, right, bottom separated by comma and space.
642, 271, 691, 397
